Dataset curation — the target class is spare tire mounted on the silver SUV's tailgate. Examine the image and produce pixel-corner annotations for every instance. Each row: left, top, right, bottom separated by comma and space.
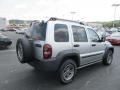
16, 38, 33, 63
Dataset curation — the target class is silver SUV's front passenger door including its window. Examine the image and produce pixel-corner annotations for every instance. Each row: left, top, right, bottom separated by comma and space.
87, 28, 105, 62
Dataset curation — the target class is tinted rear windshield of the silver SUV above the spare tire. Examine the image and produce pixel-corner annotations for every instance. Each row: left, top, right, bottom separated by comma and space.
30, 23, 47, 41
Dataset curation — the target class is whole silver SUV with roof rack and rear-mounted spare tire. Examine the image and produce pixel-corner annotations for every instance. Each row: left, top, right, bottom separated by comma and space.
16, 18, 114, 83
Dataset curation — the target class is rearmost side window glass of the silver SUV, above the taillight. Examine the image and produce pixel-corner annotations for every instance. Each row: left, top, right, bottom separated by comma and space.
54, 24, 69, 42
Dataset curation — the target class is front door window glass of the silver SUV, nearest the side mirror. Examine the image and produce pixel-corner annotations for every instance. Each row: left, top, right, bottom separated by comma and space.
88, 28, 99, 42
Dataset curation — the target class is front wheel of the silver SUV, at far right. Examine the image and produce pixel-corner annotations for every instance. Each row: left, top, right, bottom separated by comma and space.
103, 50, 113, 65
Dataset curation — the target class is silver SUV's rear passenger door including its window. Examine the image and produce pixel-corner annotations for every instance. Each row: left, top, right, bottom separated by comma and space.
71, 25, 90, 65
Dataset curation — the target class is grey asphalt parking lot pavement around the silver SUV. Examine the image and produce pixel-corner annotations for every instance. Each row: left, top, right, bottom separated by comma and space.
0, 32, 120, 90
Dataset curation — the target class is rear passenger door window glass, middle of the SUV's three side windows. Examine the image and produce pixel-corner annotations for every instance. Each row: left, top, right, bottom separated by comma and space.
72, 25, 88, 42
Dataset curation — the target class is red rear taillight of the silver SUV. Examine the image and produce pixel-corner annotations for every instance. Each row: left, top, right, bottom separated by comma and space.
43, 44, 52, 59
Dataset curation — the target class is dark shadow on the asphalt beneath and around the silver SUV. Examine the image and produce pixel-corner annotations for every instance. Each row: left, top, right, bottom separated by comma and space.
0, 63, 112, 90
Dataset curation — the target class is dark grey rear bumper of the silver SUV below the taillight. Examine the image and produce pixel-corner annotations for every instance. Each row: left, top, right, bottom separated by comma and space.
28, 58, 60, 71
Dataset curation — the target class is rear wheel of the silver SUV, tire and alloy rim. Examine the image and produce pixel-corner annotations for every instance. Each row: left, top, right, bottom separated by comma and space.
59, 59, 77, 84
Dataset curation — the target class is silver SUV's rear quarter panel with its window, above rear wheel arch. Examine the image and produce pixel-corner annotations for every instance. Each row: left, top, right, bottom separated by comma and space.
51, 21, 72, 57
